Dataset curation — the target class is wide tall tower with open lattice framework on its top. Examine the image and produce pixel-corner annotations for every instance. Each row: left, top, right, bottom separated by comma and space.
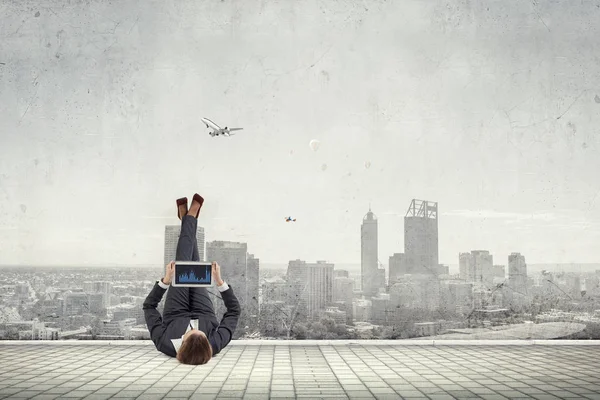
404, 199, 439, 275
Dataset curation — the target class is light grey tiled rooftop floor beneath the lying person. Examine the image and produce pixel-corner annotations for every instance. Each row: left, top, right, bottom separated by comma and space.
0, 341, 600, 399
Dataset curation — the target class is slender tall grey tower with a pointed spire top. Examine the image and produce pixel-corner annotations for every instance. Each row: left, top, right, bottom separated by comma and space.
360, 207, 379, 297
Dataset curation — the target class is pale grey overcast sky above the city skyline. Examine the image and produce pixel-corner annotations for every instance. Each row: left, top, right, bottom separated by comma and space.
0, 0, 600, 265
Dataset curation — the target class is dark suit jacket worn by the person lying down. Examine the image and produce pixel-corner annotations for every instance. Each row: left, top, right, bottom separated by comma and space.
142, 281, 241, 357
